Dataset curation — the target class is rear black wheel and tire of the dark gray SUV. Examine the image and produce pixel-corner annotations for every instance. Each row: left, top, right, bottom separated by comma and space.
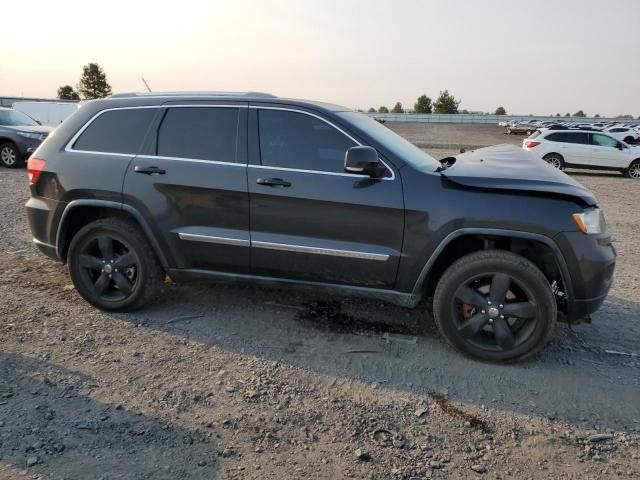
67, 218, 165, 311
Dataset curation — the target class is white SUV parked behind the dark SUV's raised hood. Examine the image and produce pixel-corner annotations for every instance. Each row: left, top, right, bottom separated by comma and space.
522, 130, 640, 179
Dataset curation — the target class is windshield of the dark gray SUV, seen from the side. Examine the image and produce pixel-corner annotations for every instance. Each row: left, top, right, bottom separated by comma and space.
337, 112, 441, 172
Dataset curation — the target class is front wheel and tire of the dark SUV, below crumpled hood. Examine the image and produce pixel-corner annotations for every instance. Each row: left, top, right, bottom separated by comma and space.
433, 250, 558, 362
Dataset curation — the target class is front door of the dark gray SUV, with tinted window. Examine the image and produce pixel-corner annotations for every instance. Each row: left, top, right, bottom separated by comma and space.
248, 107, 404, 288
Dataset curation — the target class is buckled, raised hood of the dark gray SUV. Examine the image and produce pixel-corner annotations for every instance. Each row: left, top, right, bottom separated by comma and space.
441, 144, 597, 205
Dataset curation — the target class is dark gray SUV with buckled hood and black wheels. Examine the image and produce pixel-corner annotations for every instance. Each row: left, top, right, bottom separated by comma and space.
27, 93, 615, 361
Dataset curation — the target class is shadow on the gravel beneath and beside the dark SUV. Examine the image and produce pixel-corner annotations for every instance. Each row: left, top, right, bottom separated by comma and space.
115, 282, 640, 431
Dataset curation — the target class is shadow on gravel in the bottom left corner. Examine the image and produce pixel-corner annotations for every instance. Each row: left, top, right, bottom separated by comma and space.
0, 352, 218, 480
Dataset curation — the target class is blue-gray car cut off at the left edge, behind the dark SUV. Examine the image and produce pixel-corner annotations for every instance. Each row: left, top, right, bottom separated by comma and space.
0, 107, 53, 168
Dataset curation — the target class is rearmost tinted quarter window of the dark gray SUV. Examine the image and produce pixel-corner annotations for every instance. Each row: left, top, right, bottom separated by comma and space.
73, 108, 157, 155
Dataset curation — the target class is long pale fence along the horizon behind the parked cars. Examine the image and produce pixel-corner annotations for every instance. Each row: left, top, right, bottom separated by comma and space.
367, 113, 633, 123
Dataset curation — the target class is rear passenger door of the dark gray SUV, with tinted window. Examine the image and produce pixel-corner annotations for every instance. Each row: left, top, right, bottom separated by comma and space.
124, 103, 250, 272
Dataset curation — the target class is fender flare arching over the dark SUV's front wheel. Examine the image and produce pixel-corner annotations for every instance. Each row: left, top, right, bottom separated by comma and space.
411, 228, 573, 314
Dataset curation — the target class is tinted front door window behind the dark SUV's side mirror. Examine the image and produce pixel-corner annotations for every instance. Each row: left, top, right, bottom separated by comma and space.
258, 110, 357, 173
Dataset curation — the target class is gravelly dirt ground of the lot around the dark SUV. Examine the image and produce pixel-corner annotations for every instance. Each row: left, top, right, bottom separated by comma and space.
0, 124, 640, 480
